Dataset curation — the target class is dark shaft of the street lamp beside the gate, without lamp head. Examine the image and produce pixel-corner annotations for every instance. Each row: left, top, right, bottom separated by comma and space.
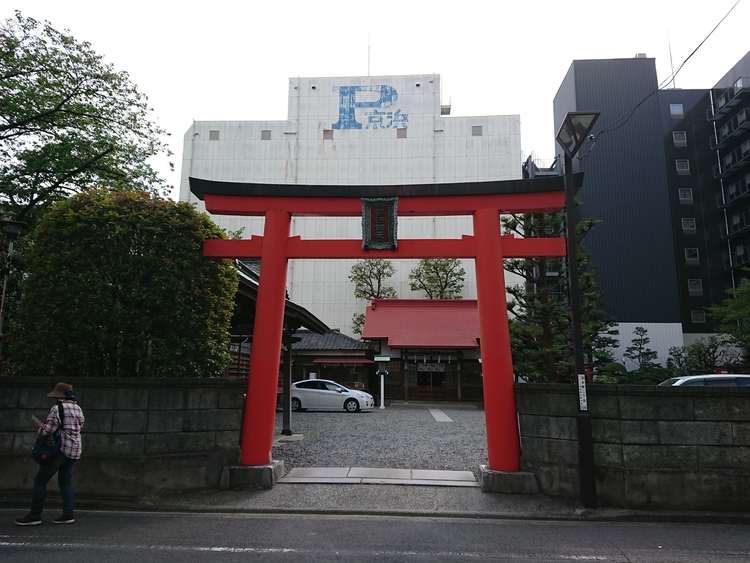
565, 153, 597, 508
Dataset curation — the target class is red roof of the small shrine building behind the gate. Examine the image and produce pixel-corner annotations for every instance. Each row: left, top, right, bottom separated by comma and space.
362, 299, 479, 348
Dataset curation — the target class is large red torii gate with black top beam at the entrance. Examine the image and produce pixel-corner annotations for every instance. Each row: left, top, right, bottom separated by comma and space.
190, 176, 565, 472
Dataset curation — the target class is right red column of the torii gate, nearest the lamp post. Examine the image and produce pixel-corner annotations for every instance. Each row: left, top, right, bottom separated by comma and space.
474, 209, 521, 471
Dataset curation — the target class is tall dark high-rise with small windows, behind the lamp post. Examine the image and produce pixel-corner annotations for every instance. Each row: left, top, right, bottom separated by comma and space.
554, 53, 750, 361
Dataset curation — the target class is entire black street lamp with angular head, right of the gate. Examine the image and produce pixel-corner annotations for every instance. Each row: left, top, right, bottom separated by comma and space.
556, 111, 600, 508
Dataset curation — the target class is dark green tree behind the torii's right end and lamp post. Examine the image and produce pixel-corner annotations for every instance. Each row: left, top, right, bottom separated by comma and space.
502, 213, 617, 381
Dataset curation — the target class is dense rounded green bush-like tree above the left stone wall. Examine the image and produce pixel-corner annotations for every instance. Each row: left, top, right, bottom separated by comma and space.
10, 190, 238, 379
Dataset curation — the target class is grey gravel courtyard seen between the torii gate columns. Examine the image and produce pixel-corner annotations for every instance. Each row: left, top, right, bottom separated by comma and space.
273, 405, 487, 475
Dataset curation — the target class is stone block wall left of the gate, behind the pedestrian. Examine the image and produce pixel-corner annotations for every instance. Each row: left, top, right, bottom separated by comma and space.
0, 377, 247, 499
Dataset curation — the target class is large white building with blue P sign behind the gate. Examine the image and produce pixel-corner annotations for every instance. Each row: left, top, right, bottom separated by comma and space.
180, 74, 522, 334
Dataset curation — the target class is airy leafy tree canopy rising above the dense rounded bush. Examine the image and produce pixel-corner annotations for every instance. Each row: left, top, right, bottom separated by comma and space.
0, 12, 171, 225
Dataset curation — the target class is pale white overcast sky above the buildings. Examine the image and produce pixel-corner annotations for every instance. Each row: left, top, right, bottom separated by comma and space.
11, 0, 750, 198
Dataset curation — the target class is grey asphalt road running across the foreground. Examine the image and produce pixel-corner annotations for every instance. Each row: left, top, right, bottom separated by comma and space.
0, 509, 750, 563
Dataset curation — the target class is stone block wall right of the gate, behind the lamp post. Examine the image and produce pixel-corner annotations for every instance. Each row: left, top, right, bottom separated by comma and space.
516, 384, 750, 511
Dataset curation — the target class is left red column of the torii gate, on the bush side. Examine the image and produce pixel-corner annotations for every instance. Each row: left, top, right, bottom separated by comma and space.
240, 210, 292, 465
